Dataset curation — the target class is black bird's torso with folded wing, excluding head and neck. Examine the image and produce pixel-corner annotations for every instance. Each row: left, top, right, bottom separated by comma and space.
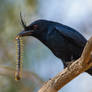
47, 23, 87, 62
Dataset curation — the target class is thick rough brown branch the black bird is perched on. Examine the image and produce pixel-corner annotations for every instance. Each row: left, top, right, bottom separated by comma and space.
38, 37, 92, 92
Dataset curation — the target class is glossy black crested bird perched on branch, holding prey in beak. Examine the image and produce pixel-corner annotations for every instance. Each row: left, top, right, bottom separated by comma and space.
18, 17, 92, 74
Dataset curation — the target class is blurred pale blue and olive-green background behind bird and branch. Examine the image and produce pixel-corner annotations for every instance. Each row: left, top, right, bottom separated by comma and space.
0, 0, 92, 92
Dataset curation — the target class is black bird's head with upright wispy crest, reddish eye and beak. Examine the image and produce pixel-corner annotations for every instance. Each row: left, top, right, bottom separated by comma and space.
18, 13, 48, 37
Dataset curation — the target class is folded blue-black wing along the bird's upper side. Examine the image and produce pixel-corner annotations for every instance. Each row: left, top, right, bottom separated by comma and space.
55, 25, 87, 47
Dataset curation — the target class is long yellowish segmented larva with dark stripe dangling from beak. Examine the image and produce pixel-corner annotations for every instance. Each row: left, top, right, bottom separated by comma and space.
15, 36, 23, 80
